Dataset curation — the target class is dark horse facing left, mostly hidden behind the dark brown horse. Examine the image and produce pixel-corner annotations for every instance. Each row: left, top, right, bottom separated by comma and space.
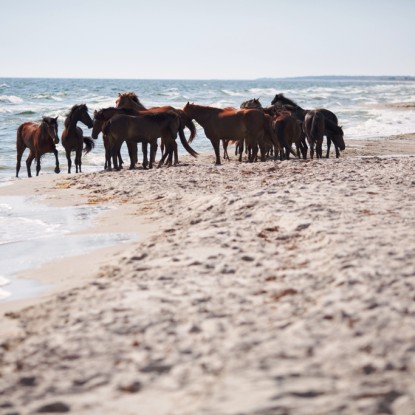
91, 107, 145, 170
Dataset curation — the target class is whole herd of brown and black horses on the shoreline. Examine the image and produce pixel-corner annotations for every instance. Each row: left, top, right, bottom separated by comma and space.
16, 92, 345, 177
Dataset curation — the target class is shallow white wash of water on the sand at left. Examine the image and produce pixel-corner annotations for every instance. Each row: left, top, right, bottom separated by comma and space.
0, 196, 137, 301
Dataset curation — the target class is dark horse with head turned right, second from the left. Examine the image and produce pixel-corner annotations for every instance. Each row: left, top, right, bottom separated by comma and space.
62, 104, 95, 173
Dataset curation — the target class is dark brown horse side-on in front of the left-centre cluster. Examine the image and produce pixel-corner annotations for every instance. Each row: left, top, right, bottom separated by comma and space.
103, 111, 193, 169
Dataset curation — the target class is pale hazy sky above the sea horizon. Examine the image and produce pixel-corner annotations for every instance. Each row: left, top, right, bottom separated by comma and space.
0, 0, 415, 79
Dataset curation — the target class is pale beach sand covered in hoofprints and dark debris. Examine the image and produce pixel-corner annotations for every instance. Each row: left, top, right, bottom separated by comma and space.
0, 135, 415, 415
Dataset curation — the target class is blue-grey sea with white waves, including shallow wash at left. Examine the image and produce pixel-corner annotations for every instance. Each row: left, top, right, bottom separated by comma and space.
0, 77, 415, 301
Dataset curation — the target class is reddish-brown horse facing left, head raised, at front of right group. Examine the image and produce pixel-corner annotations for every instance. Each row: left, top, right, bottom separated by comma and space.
183, 103, 270, 165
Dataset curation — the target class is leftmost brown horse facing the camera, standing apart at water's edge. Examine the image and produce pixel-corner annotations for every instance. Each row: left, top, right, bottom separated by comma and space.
16, 117, 60, 177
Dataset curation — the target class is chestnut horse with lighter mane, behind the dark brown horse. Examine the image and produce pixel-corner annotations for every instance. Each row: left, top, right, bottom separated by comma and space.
115, 92, 196, 165
